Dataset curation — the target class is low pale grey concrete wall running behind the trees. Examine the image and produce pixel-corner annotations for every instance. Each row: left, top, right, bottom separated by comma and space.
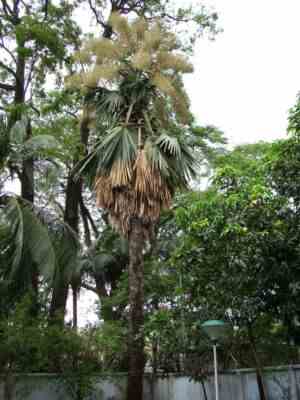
0, 366, 300, 400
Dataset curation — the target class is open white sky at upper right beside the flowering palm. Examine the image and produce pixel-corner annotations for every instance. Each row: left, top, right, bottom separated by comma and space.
185, 0, 300, 146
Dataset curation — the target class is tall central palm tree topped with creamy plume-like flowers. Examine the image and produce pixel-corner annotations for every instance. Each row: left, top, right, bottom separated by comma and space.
69, 14, 196, 400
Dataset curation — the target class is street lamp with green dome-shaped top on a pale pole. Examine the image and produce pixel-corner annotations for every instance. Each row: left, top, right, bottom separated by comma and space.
201, 320, 227, 400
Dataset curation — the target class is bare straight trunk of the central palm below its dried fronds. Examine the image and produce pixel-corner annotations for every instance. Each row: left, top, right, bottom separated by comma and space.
127, 218, 145, 400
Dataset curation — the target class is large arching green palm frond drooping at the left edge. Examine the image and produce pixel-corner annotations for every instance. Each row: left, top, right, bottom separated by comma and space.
0, 196, 79, 292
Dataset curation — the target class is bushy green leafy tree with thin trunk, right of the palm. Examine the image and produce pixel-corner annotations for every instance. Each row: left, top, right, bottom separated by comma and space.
174, 143, 299, 400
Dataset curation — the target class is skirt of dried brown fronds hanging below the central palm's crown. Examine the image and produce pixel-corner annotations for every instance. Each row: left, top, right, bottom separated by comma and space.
95, 150, 172, 235
